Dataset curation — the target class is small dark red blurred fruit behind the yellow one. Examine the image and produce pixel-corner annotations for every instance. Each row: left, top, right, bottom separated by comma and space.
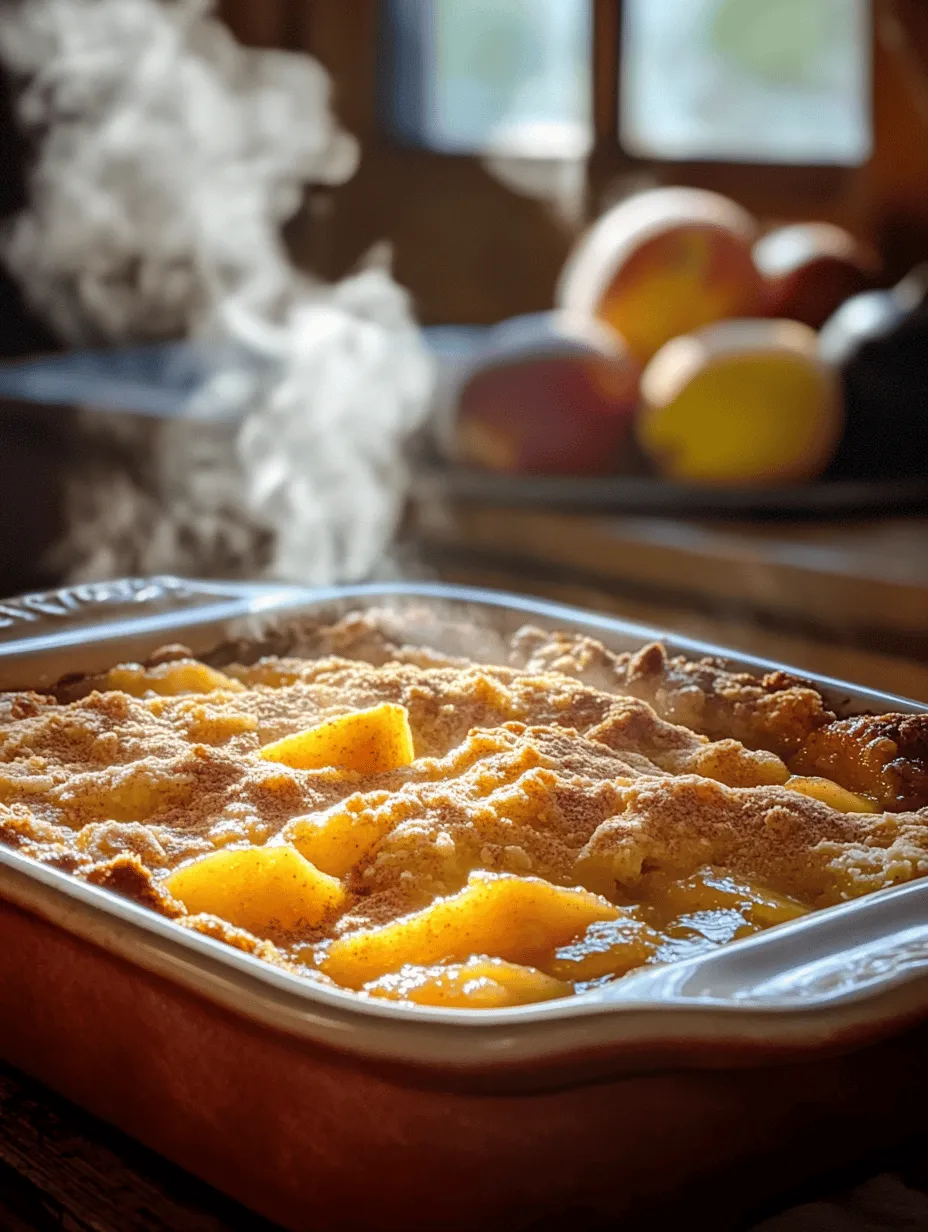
754, 223, 880, 329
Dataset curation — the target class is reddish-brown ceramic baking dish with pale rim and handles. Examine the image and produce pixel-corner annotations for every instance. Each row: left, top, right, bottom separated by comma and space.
0, 578, 928, 1230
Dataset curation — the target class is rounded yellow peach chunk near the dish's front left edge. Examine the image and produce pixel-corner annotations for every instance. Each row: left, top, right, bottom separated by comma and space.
165, 846, 345, 936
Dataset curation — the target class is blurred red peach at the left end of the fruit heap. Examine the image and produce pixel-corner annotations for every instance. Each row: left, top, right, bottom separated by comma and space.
439, 313, 641, 474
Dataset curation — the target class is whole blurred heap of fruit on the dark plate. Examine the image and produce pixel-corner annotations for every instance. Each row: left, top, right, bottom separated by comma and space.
438, 188, 928, 487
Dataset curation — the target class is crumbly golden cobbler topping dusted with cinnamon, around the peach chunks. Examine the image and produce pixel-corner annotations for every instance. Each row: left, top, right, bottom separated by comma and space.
0, 617, 928, 1000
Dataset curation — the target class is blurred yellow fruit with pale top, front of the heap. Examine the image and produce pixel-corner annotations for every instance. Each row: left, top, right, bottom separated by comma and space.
637, 320, 843, 484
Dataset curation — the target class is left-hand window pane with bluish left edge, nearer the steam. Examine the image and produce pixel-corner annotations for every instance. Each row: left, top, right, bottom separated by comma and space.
381, 0, 592, 158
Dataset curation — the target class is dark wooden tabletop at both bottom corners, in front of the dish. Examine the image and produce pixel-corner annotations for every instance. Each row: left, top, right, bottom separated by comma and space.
0, 1049, 928, 1232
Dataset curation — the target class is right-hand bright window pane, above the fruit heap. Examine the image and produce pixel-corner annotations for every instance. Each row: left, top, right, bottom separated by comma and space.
620, 0, 871, 166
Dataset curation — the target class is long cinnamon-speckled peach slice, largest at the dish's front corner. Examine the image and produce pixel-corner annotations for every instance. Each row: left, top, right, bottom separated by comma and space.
320, 872, 620, 988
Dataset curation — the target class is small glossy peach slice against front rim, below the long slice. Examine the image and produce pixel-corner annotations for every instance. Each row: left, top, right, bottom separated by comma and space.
364, 957, 573, 1009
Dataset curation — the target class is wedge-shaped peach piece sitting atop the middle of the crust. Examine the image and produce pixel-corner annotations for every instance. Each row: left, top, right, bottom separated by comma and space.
260, 701, 415, 774
